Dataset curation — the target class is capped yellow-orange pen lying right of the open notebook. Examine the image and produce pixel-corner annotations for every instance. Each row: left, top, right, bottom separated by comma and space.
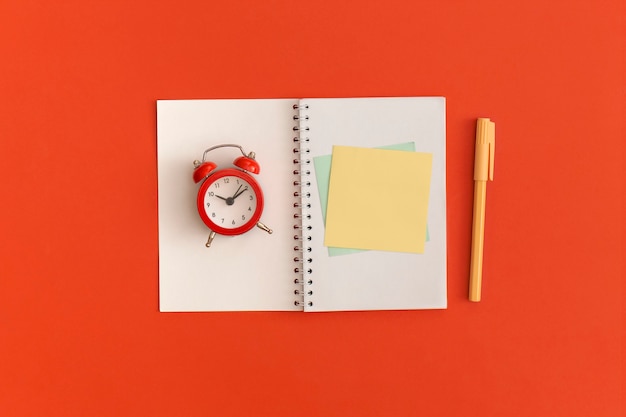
469, 118, 496, 301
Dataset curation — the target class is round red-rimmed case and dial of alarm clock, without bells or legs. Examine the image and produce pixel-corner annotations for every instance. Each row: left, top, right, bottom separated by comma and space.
198, 168, 263, 235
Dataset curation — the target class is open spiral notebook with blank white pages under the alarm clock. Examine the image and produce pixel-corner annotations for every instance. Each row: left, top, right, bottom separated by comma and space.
157, 97, 447, 312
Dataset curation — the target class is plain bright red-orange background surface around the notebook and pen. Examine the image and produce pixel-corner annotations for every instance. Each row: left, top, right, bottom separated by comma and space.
0, 0, 626, 417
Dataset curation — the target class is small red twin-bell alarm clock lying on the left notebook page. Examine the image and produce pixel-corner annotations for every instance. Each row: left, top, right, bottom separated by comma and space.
193, 144, 272, 248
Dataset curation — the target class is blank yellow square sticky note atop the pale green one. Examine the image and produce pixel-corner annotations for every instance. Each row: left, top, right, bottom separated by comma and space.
324, 146, 432, 253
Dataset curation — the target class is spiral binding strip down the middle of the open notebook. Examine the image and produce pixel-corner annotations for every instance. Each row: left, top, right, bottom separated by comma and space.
293, 104, 313, 307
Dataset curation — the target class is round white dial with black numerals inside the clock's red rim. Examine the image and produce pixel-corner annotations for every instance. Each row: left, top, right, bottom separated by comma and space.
204, 175, 257, 229
